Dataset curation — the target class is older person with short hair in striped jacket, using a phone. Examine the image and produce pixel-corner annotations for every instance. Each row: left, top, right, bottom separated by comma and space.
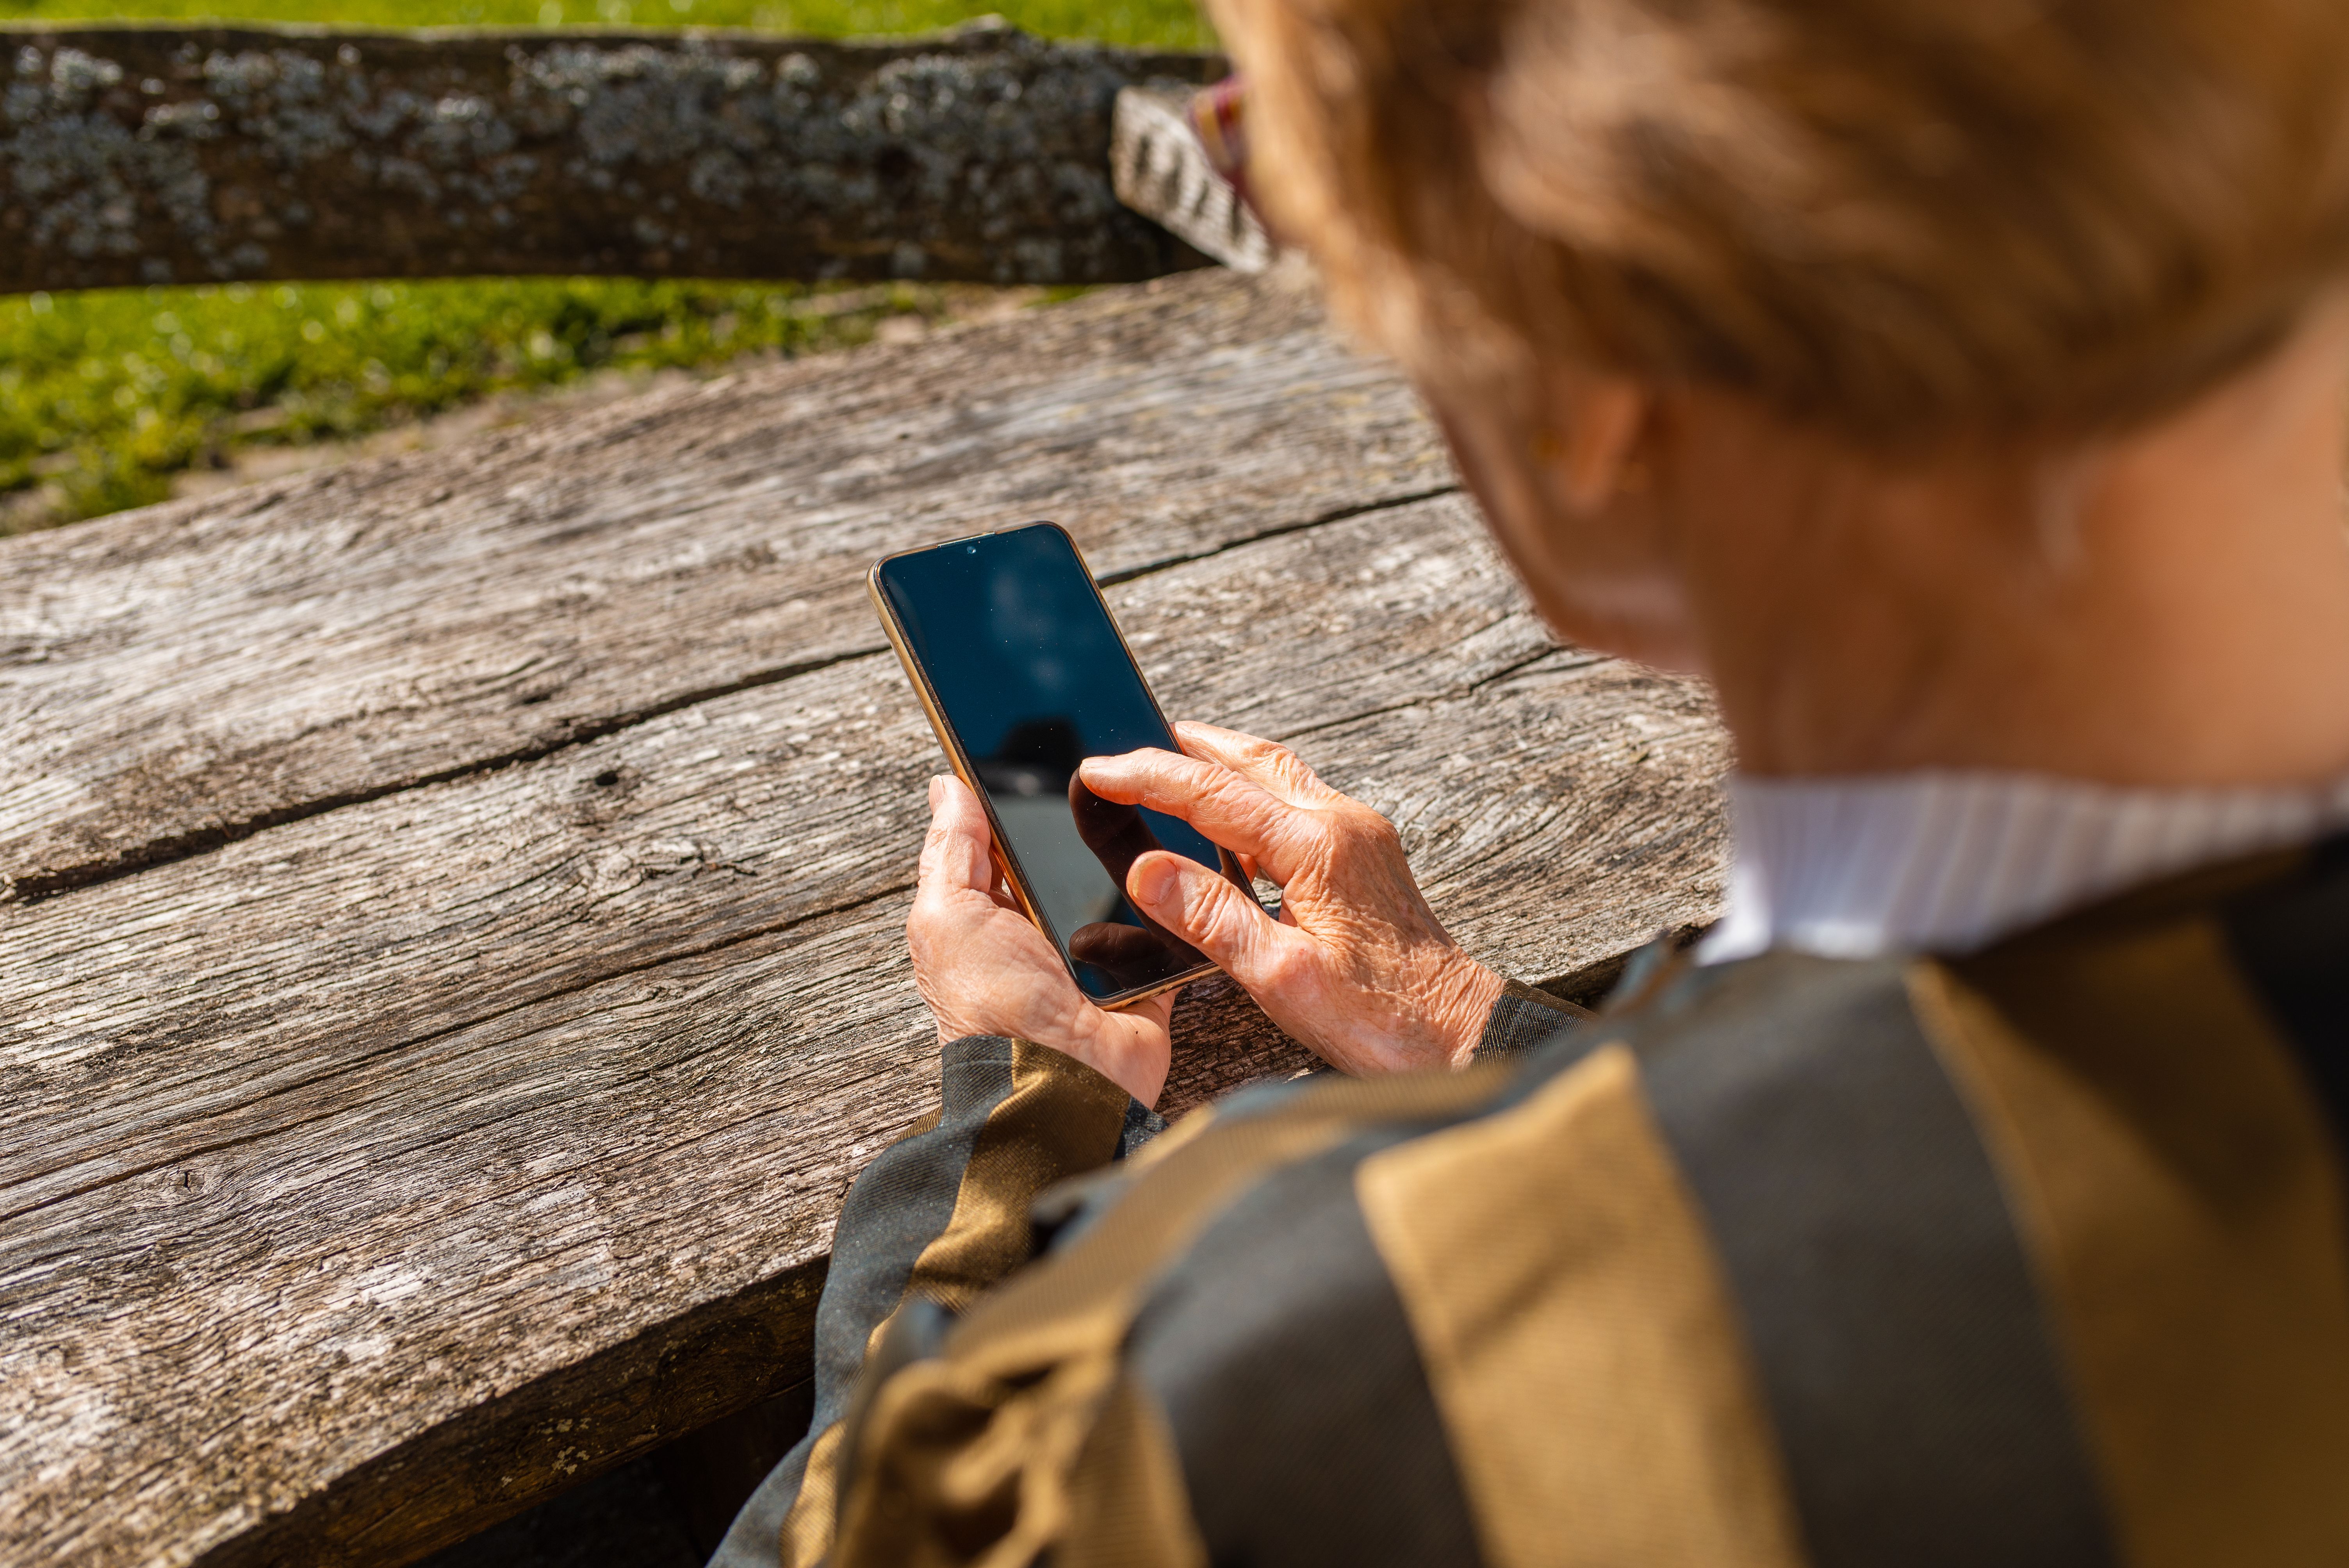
724, 0, 2349, 1568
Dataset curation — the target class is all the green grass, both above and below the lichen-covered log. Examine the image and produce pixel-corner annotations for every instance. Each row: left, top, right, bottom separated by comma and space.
0, 0, 1212, 533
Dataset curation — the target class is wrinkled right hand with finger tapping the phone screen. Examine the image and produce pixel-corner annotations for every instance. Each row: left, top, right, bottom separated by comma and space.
1080, 723, 1503, 1075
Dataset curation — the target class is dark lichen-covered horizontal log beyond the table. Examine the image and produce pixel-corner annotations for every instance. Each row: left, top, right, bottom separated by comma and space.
0, 23, 1221, 291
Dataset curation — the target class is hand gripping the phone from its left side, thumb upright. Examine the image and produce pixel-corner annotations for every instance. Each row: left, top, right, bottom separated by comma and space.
904, 777, 1174, 1106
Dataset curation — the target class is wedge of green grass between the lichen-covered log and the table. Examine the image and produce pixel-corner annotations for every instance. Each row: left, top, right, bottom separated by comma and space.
0, 279, 982, 531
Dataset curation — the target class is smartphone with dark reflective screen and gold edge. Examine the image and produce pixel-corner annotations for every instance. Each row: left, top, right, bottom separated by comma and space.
864, 524, 1255, 1007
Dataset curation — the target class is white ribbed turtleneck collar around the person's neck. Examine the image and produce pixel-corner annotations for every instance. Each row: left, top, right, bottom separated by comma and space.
1698, 772, 2349, 962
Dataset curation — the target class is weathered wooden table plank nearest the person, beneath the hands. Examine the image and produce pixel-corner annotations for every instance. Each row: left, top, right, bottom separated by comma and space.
0, 498, 1727, 1563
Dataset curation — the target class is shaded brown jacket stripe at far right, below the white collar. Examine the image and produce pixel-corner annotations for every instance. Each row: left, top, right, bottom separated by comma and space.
1912, 923, 2349, 1568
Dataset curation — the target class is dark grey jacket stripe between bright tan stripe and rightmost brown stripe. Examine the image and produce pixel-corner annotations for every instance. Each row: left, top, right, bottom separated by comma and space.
1644, 958, 2114, 1568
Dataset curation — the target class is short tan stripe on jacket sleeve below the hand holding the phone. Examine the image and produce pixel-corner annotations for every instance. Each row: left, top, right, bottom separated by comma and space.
907, 1040, 1130, 1312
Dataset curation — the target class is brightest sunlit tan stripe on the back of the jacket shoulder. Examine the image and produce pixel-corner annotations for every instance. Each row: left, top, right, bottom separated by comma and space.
1355, 1044, 1804, 1568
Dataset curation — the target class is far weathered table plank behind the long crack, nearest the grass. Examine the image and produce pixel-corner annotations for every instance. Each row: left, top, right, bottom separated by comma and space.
0, 272, 1452, 897
